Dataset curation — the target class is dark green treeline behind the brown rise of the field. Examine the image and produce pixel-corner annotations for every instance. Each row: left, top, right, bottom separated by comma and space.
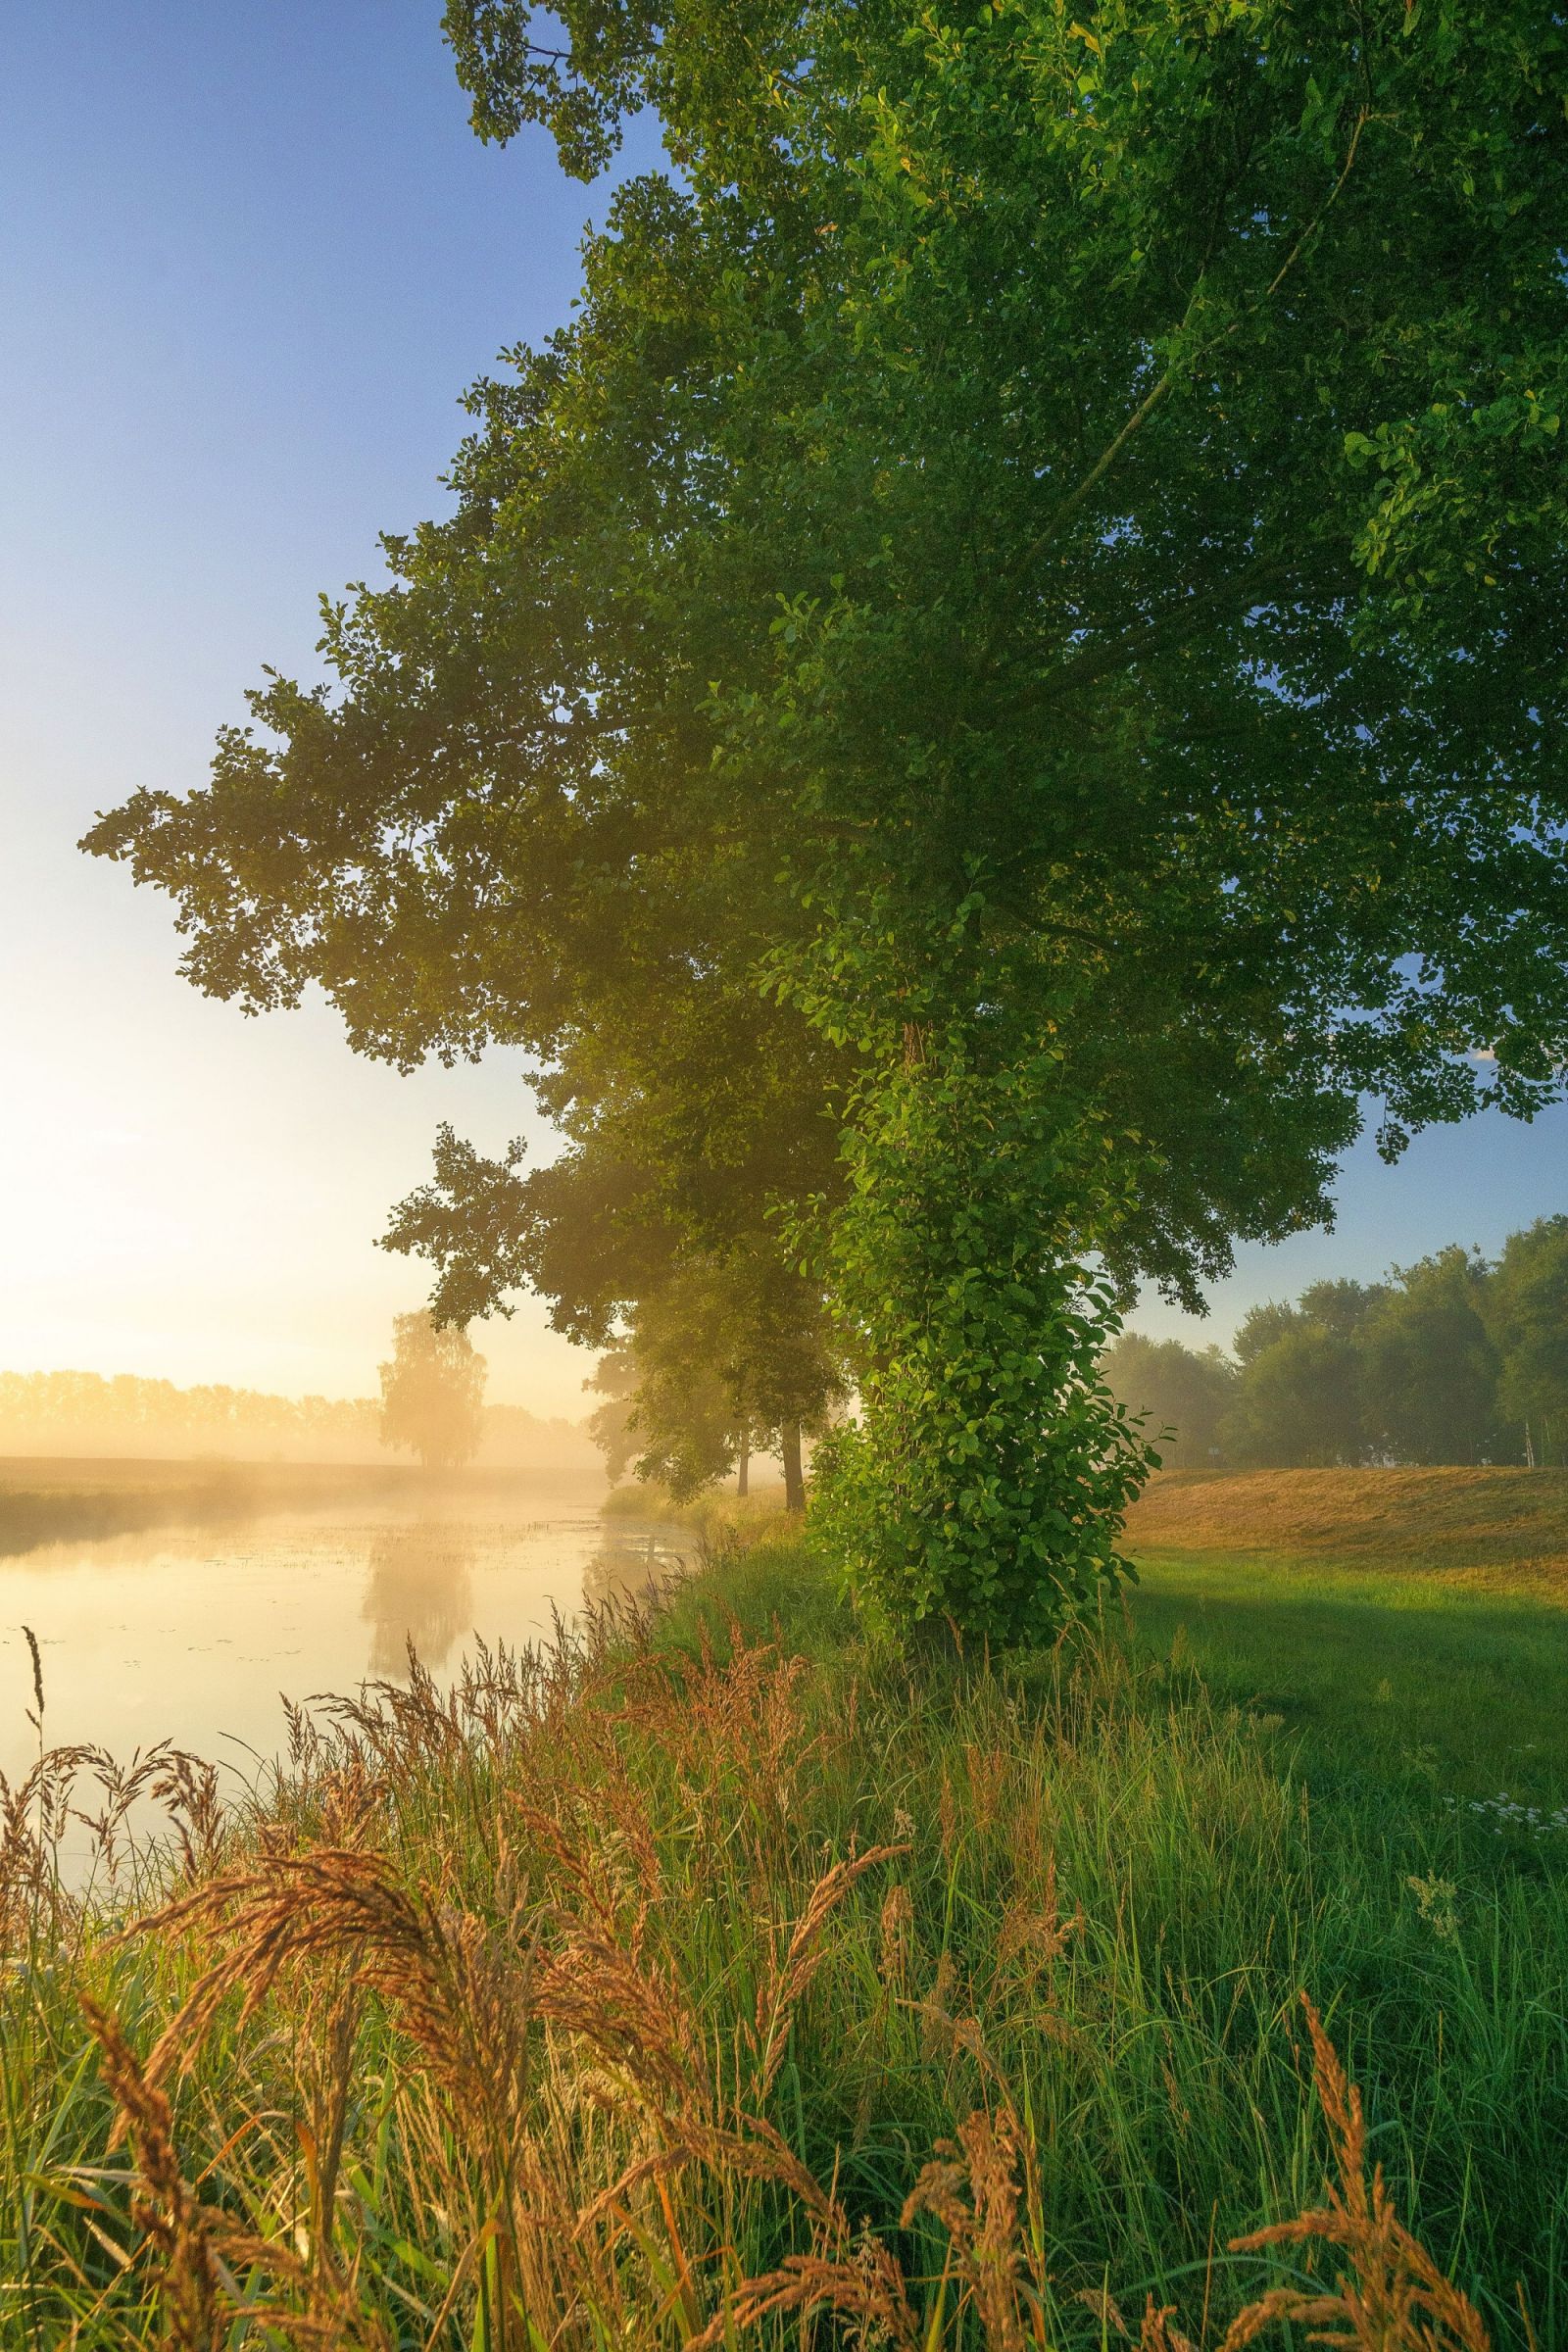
1104, 1216, 1568, 1470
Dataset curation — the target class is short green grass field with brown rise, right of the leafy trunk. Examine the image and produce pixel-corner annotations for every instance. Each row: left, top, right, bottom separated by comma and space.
1126, 1470, 1568, 1806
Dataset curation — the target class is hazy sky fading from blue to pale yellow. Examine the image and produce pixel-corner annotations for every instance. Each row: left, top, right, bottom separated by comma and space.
0, 0, 1568, 1413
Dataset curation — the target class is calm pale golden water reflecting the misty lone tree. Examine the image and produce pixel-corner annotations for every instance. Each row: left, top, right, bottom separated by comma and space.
0, 1475, 689, 1788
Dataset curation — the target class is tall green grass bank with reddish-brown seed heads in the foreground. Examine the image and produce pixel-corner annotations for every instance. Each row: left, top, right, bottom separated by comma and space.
0, 1503, 1568, 2352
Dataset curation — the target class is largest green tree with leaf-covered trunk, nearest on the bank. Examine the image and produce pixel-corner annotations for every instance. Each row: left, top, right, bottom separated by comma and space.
89, 0, 1568, 1633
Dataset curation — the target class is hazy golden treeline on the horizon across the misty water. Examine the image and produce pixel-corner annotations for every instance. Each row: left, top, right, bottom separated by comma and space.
0, 1371, 597, 1470
